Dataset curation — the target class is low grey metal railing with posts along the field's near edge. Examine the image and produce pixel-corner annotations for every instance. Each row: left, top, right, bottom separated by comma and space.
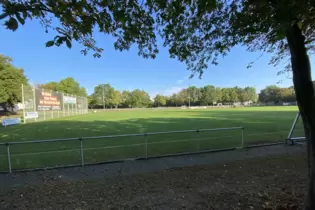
0, 127, 244, 173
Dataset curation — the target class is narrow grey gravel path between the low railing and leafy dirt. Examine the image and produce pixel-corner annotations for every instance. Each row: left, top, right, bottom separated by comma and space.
0, 145, 305, 188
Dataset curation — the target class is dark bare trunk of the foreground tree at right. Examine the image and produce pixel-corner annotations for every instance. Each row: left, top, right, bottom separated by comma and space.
286, 24, 315, 210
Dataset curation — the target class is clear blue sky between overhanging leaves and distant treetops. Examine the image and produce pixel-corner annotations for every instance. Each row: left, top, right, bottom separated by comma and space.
0, 18, 314, 96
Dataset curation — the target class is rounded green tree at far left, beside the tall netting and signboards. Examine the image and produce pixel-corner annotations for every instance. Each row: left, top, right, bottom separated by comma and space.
0, 55, 28, 111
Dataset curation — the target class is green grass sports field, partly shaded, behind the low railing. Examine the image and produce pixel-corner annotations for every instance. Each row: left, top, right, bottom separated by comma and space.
0, 107, 303, 171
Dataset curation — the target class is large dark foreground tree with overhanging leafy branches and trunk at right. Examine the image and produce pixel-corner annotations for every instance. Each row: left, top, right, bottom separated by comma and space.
0, 0, 315, 209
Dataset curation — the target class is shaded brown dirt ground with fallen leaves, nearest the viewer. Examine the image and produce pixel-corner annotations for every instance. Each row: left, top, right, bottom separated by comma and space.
0, 154, 307, 210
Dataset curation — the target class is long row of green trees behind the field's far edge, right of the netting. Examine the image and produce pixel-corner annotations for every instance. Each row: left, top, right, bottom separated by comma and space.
89, 84, 257, 108
